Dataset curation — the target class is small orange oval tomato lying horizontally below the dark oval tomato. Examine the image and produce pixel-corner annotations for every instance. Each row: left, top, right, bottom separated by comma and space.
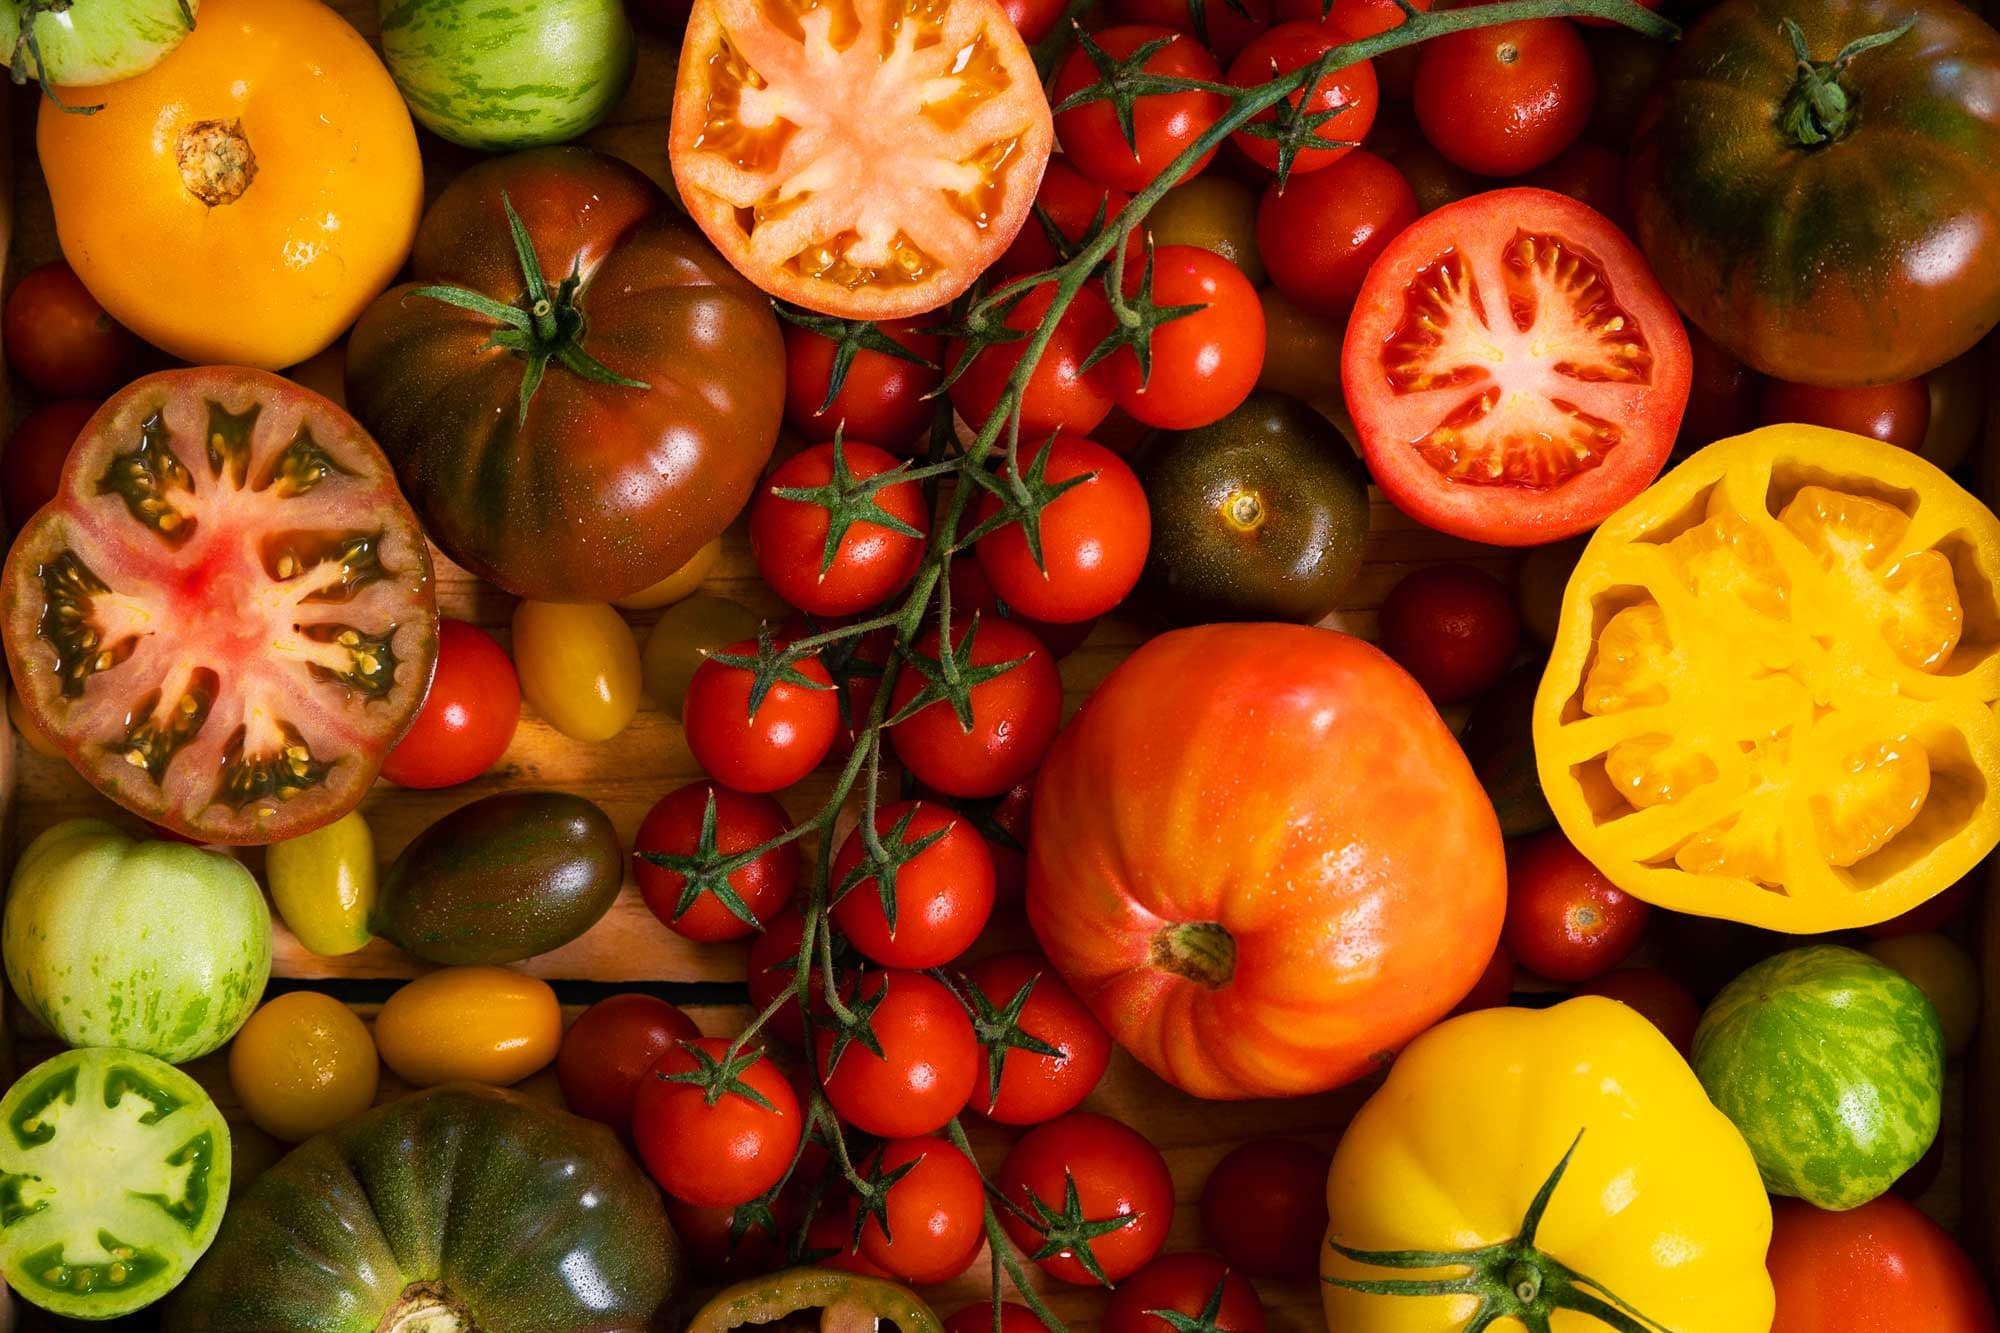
376, 967, 562, 1087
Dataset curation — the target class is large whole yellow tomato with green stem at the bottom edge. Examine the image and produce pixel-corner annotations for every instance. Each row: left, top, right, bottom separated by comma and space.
1320, 997, 1774, 1333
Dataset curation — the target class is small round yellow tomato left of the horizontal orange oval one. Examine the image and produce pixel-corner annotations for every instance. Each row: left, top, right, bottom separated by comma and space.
230, 991, 382, 1143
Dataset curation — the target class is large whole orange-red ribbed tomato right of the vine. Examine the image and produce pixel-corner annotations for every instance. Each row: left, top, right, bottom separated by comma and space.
1028, 624, 1506, 1097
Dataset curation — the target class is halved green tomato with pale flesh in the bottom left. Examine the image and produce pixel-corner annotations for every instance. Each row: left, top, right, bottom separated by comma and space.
0, 1047, 230, 1319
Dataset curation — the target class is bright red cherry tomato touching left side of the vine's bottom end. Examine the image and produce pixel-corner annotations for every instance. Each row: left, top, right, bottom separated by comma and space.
862, 1135, 986, 1287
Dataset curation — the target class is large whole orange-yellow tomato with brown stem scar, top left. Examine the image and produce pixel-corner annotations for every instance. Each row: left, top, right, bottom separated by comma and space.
36, 0, 424, 370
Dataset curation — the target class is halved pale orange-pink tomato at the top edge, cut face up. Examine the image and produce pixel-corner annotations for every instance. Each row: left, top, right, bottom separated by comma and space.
670, 0, 1054, 318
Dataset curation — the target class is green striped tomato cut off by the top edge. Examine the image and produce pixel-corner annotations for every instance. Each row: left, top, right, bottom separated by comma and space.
382, 0, 638, 152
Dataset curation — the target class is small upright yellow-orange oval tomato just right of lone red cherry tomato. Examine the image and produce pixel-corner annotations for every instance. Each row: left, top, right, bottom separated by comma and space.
514, 602, 640, 741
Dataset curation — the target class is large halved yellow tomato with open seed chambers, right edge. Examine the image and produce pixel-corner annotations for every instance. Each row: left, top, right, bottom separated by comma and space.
1534, 426, 2000, 933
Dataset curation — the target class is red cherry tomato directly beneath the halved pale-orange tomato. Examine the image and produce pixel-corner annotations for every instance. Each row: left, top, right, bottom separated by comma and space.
784, 318, 944, 454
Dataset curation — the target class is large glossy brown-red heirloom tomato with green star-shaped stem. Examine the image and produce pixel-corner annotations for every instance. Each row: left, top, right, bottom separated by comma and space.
348, 148, 784, 602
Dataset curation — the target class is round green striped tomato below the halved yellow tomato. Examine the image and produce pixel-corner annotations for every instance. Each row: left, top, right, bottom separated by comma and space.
1694, 945, 1944, 1211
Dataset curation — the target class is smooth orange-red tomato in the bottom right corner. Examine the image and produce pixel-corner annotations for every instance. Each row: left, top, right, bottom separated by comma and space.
1768, 1195, 2000, 1333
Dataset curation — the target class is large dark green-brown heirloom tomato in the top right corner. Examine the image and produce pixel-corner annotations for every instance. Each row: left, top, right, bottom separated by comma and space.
1628, 0, 2000, 384
